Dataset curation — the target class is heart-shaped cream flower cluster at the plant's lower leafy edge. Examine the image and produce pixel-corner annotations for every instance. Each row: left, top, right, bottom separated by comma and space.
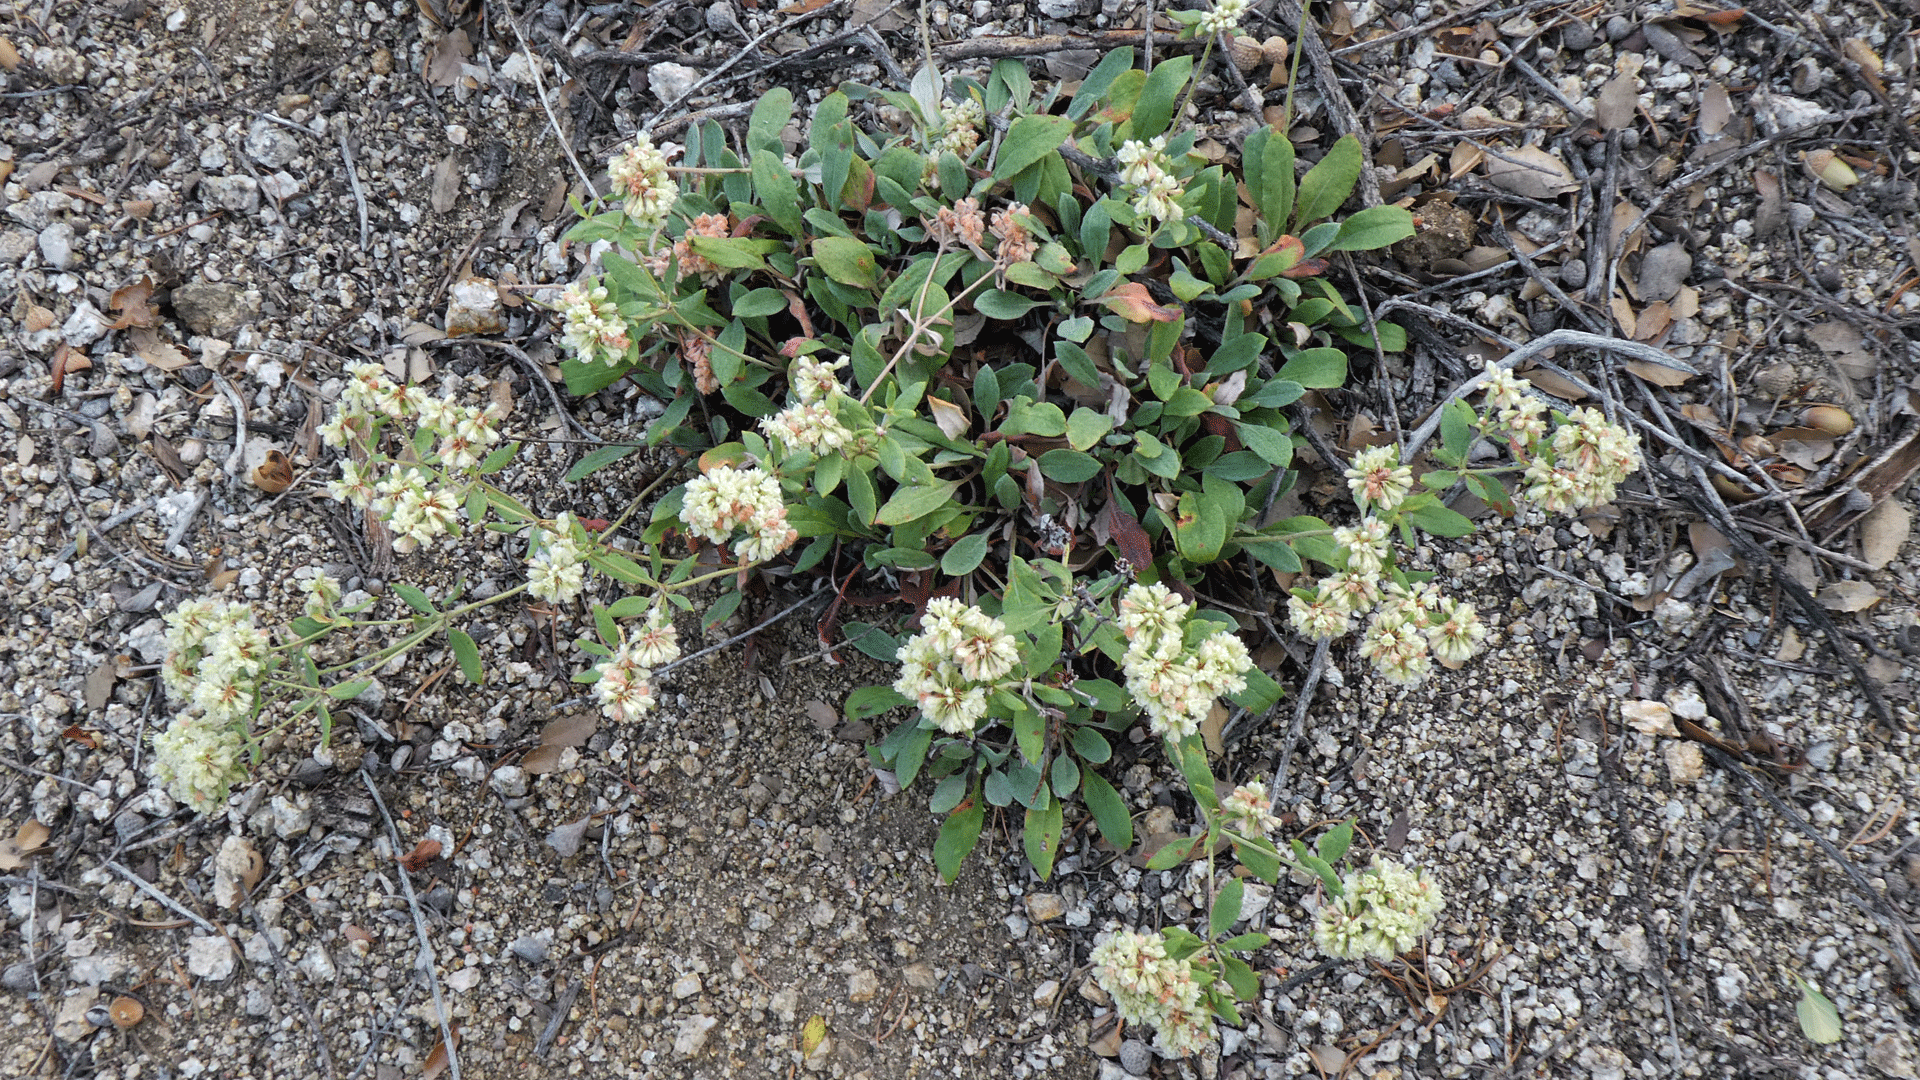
1119, 584, 1254, 740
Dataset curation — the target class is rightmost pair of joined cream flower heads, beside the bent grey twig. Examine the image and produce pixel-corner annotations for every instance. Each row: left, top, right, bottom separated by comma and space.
1480, 363, 1640, 513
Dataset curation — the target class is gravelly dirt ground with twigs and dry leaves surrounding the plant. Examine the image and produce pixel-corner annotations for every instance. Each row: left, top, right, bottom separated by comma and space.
0, 0, 1920, 1080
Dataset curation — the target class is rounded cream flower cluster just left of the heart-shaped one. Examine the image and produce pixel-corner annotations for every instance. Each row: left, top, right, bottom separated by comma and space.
893, 596, 1020, 734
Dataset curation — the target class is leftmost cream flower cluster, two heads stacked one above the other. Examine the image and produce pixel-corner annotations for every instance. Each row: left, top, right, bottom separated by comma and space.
150, 600, 271, 811
